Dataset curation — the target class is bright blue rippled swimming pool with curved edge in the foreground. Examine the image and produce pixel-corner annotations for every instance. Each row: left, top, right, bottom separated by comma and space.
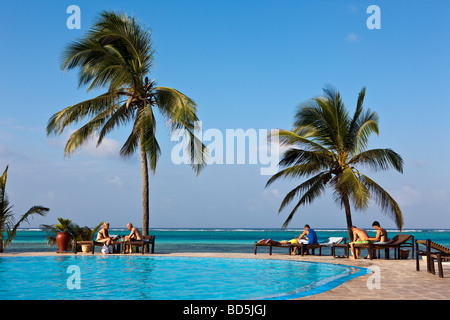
0, 255, 367, 300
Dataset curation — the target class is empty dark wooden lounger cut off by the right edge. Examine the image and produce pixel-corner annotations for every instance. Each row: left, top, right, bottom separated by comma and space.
416, 239, 450, 278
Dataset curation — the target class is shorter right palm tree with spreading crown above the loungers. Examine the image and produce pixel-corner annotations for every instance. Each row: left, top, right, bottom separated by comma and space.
266, 88, 403, 240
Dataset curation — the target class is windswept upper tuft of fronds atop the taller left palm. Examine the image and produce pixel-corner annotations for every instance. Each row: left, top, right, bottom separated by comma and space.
61, 11, 154, 90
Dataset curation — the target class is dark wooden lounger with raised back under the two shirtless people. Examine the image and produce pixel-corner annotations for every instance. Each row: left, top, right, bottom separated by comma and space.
353, 234, 414, 259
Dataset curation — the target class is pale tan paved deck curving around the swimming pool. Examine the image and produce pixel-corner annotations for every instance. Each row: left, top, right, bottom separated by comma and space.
0, 252, 450, 300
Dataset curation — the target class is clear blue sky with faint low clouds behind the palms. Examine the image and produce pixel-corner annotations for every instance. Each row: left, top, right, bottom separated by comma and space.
0, 0, 450, 229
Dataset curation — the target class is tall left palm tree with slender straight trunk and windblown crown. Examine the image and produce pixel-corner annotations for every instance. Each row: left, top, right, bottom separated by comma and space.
47, 11, 206, 235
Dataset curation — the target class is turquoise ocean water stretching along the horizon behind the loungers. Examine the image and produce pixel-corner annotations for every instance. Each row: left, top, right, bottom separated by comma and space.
4, 228, 450, 254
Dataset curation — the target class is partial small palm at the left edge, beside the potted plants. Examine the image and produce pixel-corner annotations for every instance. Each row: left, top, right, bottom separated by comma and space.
0, 166, 50, 253
